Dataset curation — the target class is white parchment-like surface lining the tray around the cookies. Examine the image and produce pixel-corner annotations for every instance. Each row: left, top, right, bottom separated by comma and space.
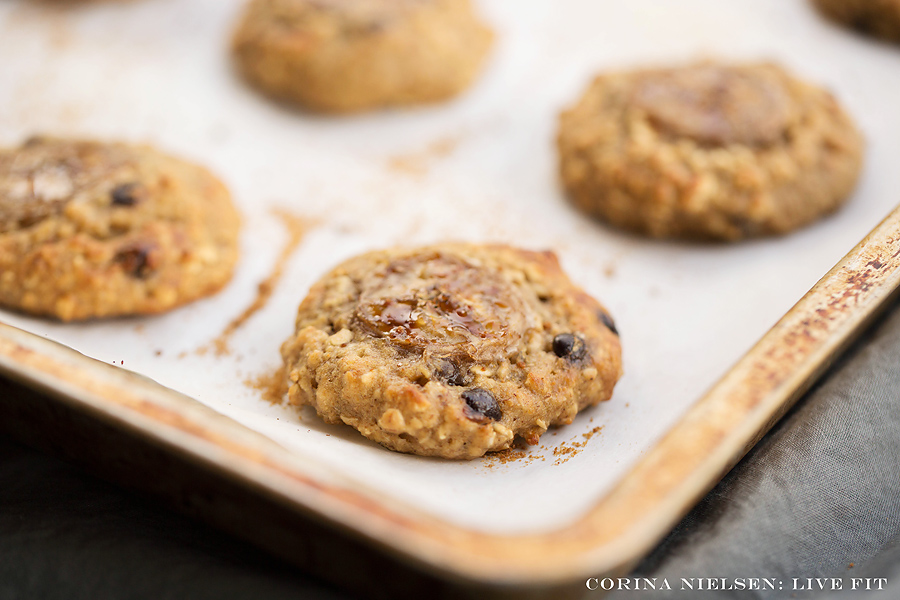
0, 0, 900, 533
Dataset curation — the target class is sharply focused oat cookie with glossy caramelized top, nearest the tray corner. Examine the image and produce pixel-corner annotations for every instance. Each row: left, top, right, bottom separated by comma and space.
281, 244, 622, 459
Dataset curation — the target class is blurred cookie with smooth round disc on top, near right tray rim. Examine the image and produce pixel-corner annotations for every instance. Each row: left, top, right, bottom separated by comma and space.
557, 62, 863, 241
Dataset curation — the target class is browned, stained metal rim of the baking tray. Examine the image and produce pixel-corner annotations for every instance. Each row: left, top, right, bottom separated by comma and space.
0, 207, 900, 587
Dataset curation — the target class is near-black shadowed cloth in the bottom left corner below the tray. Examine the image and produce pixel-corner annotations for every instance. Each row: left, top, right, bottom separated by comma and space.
0, 437, 347, 600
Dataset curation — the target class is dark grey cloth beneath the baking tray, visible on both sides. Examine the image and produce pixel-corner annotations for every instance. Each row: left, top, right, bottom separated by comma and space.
0, 304, 900, 600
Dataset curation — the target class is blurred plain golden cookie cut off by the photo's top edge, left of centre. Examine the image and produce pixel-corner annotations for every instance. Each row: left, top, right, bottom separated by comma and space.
232, 0, 493, 113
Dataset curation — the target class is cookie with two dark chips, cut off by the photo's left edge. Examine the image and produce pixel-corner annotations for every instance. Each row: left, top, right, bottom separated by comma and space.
0, 138, 239, 321
